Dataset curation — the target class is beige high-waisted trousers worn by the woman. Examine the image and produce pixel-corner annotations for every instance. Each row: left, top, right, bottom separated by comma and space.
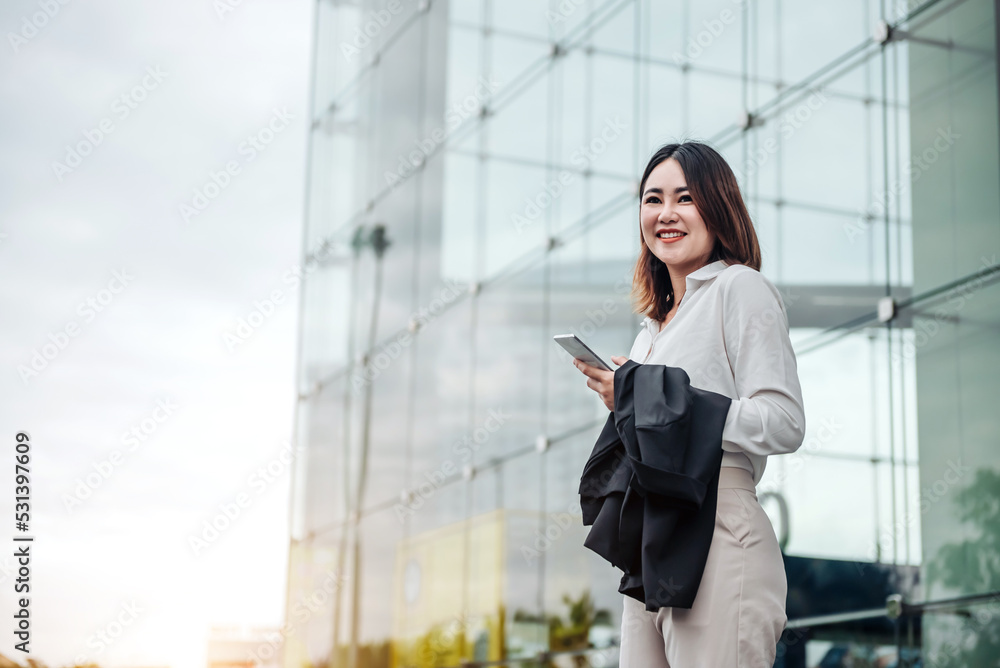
620, 466, 788, 668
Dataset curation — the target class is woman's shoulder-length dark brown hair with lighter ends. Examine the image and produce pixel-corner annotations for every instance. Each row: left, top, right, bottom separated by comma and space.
632, 141, 760, 321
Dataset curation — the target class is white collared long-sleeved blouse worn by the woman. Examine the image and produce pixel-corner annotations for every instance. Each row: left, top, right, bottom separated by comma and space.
629, 260, 806, 484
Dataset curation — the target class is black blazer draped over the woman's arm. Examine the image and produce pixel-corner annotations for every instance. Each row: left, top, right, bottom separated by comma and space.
580, 360, 732, 611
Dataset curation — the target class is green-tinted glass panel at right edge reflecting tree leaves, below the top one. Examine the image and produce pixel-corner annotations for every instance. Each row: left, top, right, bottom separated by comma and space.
914, 279, 1000, 598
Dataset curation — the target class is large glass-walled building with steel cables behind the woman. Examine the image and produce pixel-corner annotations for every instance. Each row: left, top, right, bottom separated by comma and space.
282, 0, 1000, 668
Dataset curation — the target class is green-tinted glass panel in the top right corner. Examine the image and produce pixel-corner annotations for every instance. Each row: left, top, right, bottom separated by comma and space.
910, 2, 1000, 292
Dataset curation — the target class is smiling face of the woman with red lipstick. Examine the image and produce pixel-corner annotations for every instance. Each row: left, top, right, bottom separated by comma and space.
639, 158, 715, 276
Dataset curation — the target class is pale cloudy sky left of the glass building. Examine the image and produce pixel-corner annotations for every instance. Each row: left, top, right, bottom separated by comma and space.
0, 0, 312, 668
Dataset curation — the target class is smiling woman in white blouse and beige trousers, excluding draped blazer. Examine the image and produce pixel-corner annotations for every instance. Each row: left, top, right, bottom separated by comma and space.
574, 142, 805, 668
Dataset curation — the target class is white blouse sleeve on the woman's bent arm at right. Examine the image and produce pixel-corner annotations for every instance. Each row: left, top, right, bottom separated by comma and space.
722, 270, 806, 455
